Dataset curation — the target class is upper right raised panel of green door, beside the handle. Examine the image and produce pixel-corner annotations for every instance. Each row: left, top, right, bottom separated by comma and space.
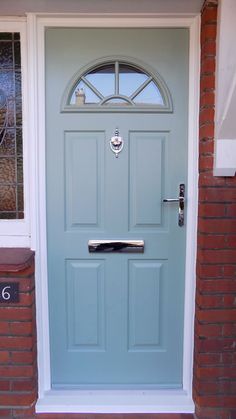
129, 132, 168, 230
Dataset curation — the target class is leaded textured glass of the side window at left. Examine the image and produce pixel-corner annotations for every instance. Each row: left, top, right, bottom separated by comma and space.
0, 32, 24, 219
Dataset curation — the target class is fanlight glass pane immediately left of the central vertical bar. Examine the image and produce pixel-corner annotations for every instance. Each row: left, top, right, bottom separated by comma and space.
85, 64, 115, 97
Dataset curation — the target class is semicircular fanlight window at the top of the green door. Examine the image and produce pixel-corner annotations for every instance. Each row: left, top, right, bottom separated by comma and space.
62, 59, 172, 112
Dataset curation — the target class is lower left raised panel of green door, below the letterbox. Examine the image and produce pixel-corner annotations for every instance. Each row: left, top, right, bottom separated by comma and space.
66, 260, 105, 351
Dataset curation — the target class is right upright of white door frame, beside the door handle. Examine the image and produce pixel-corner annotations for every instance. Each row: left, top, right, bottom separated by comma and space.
183, 16, 201, 396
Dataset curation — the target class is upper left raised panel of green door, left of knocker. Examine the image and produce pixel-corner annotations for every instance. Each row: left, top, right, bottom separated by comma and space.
64, 131, 104, 230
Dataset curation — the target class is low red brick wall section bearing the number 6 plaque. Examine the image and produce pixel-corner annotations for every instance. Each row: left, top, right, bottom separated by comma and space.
0, 249, 37, 418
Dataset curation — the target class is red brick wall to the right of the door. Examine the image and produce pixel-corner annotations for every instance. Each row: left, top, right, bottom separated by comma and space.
193, 0, 236, 419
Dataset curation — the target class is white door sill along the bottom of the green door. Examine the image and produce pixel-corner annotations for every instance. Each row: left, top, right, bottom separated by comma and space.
36, 390, 194, 413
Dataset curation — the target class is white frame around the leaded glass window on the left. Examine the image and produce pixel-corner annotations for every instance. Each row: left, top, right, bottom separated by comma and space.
0, 17, 30, 247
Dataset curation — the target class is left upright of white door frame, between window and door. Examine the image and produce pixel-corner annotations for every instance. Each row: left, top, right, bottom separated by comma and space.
27, 14, 51, 398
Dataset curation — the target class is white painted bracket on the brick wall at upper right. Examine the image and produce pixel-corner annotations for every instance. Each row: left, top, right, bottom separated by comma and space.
214, 0, 236, 176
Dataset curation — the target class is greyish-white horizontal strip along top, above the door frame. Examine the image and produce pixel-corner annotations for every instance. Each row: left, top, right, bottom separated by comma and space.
0, 0, 204, 16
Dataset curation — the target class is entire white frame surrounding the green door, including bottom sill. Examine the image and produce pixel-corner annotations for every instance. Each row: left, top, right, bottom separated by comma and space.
27, 14, 200, 413
